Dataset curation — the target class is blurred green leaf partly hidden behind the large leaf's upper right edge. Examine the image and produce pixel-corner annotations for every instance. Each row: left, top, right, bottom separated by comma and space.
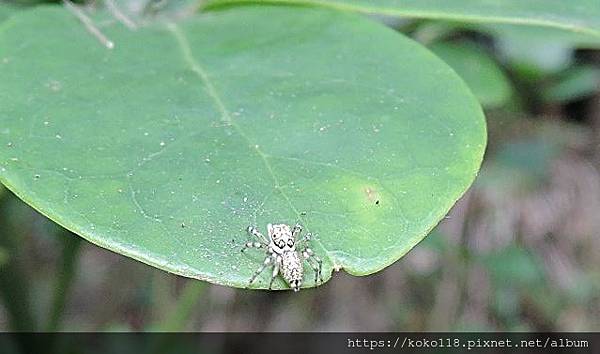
430, 43, 512, 108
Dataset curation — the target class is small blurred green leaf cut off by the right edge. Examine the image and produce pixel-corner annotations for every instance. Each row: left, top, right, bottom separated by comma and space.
542, 65, 600, 102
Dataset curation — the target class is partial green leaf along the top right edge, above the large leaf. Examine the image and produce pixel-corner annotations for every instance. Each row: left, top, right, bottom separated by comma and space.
204, 0, 600, 38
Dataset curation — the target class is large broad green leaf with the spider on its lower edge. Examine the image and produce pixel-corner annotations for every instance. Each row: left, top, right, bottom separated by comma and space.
0, 7, 486, 288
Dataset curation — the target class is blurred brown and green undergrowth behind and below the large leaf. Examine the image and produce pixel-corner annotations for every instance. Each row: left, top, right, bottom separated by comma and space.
0, 0, 600, 331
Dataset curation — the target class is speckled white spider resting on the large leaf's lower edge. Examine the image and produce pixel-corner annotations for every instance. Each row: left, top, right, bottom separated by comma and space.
242, 224, 323, 291
